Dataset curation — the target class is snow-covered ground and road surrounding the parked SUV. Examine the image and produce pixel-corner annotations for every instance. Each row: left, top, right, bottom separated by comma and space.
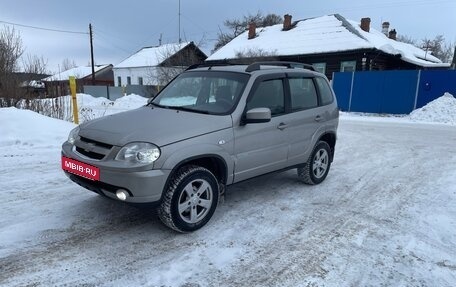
0, 94, 456, 286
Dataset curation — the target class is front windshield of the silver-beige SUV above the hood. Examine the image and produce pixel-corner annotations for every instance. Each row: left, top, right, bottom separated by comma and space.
151, 71, 249, 114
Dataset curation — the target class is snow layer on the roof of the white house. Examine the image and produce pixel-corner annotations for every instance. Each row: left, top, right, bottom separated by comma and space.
114, 42, 191, 68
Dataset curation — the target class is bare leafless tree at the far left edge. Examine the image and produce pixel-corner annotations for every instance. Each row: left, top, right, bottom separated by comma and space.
0, 26, 24, 107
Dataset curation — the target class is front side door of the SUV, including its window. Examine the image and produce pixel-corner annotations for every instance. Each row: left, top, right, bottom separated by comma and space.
233, 75, 288, 182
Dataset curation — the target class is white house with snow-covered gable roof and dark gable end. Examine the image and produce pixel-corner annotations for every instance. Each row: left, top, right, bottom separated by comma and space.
113, 42, 207, 87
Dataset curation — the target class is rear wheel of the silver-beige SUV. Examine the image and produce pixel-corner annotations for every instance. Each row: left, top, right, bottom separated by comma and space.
298, 141, 331, 185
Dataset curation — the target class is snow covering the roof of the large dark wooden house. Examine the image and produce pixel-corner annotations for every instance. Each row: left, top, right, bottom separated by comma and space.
207, 14, 449, 67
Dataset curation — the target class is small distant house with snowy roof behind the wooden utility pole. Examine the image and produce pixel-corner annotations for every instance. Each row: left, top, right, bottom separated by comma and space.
41, 64, 114, 96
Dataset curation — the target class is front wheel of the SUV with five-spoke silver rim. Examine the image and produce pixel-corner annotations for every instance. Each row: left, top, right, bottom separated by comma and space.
158, 165, 219, 232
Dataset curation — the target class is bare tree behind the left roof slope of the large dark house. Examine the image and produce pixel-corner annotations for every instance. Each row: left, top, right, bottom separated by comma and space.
213, 11, 283, 52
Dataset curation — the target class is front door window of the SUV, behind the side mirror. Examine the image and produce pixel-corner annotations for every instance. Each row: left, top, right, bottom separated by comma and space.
247, 79, 285, 116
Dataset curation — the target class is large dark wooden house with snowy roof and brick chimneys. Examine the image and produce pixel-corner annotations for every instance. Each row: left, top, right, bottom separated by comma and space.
206, 14, 450, 78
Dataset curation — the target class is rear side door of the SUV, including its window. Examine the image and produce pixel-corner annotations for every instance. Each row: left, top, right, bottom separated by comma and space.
287, 75, 327, 166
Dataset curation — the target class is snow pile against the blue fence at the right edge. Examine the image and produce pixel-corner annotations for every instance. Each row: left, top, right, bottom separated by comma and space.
410, 93, 456, 125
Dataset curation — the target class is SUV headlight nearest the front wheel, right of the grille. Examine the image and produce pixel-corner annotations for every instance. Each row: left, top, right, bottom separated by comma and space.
116, 142, 160, 163
